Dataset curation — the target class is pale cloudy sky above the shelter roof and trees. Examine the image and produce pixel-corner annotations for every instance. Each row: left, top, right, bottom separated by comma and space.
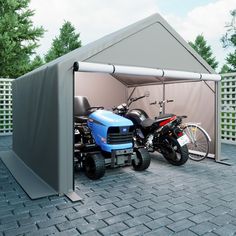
30, 0, 236, 70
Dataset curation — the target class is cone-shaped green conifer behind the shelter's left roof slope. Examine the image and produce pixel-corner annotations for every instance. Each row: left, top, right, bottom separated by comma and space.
45, 21, 81, 62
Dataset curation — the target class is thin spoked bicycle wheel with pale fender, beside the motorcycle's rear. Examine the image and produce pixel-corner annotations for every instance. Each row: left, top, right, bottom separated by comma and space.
184, 124, 209, 161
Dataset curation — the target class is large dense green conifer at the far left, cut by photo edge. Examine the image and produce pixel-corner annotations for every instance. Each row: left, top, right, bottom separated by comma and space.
0, 0, 44, 78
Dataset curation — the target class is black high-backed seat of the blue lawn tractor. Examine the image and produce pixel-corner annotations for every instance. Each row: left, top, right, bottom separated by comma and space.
74, 96, 91, 123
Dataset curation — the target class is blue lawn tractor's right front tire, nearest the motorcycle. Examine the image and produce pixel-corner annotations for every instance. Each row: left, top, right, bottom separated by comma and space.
132, 148, 151, 171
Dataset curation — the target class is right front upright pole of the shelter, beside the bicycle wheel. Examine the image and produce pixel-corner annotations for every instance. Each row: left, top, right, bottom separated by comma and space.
215, 81, 221, 162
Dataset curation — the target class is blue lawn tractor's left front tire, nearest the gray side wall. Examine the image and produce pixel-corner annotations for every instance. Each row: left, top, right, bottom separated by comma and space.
83, 153, 105, 180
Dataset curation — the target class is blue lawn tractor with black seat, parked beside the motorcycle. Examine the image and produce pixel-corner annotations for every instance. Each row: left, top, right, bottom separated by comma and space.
74, 96, 151, 180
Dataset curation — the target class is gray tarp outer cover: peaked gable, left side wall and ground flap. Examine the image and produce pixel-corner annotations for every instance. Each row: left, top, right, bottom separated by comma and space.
1, 14, 219, 198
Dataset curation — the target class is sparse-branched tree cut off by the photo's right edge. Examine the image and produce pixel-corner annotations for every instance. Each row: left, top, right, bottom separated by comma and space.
221, 9, 236, 73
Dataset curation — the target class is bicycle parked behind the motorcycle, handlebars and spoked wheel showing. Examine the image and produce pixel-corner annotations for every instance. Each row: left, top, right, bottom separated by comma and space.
150, 100, 211, 161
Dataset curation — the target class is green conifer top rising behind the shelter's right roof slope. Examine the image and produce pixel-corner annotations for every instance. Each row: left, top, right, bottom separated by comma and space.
189, 35, 218, 69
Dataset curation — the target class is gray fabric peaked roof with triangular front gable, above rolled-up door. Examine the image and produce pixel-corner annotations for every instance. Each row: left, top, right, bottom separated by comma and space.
22, 13, 215, 77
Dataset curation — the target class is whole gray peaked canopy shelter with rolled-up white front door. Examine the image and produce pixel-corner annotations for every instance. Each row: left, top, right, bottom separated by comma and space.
0, 14, 220, 199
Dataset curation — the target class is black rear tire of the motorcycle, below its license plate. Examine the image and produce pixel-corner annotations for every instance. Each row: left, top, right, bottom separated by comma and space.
162, 138, 189, 166
